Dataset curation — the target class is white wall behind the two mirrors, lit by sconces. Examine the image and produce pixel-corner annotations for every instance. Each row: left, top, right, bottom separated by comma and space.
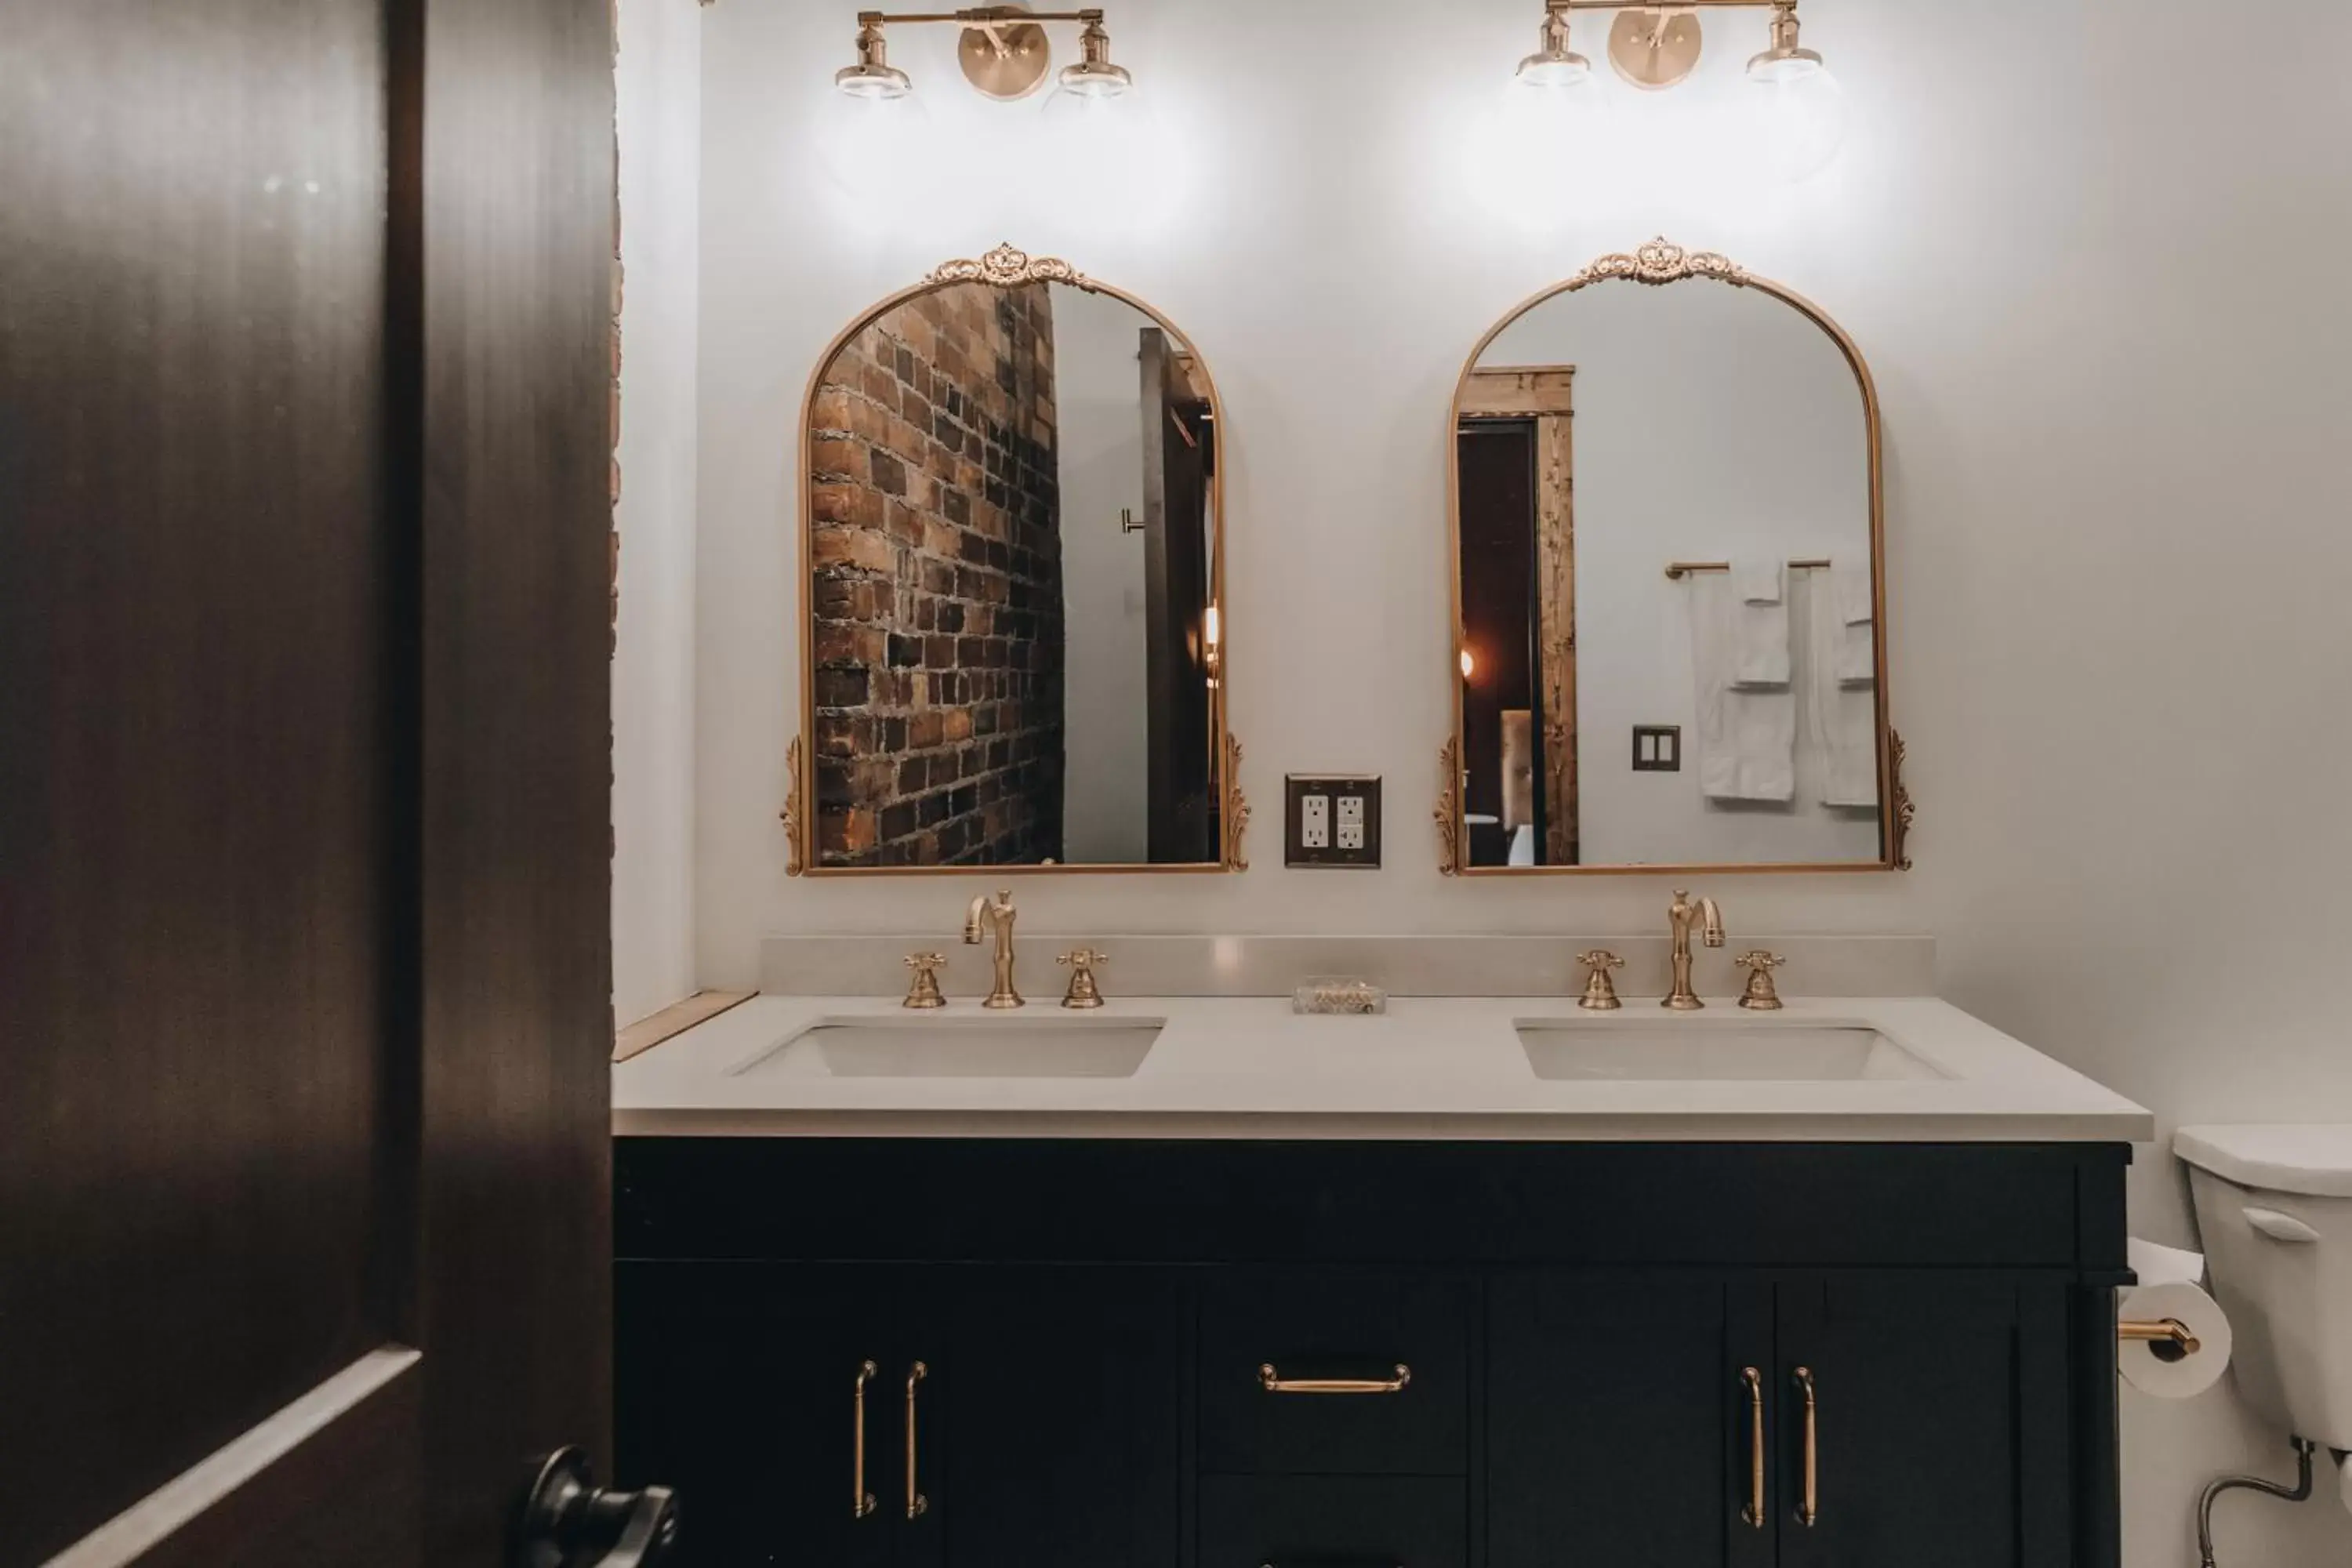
687, 0, 2352, 1568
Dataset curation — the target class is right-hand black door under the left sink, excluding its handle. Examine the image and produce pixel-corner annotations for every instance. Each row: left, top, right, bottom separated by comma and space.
924, 1267, 1190, 1568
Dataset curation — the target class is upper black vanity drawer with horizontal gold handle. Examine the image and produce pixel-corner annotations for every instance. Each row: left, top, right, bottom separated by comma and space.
1200, 1269, 1472, 1476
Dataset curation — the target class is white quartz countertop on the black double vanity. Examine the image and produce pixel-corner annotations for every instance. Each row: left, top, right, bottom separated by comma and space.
612, 996, 2154, 1142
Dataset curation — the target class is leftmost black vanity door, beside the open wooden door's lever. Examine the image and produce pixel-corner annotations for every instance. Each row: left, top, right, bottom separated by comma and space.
614, 1262, 896, 1568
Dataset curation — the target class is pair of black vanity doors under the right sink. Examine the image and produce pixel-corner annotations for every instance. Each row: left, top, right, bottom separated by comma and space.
1486, 1269, 2096, 1568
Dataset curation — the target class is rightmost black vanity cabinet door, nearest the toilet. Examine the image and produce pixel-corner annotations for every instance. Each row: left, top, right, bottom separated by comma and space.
1776, 1274, 2074, 1568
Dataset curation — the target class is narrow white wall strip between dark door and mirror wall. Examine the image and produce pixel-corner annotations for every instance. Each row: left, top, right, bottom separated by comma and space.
612, 0, 703, 1022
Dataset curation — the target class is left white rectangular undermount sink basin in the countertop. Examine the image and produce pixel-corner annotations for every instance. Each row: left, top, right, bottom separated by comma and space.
734, 1013, 1167, 1079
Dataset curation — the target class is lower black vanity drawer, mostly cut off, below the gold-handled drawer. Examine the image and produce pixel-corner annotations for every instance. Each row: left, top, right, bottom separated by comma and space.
1200, 1476, 1470, 1568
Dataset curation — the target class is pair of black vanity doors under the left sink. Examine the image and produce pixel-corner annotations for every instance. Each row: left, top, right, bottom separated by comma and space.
614, 1260, 1188, 1568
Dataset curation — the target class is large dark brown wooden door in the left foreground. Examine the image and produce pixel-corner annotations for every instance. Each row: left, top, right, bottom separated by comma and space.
0, 0, 614, 1568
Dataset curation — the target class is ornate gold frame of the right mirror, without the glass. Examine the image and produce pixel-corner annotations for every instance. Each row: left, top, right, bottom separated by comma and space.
1432, 238, 1917, 877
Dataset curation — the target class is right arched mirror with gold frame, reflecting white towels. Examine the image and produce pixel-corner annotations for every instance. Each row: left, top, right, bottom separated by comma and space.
1437, 240, 1910, 874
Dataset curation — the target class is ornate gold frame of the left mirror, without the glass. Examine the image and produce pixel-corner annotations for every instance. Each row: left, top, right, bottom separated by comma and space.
781, 245, 1249, 877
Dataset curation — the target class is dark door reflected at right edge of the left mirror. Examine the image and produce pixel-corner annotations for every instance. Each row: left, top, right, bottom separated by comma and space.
1138, 327, 1221, 865
